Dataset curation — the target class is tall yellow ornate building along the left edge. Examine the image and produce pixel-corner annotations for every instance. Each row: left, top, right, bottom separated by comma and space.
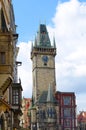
0, 0, 22, 130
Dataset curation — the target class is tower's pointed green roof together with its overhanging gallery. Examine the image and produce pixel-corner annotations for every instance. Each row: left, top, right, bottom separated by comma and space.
31, 24, 56, 59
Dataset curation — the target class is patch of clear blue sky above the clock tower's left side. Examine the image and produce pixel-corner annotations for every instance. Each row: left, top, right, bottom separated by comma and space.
13, 0, 57, 41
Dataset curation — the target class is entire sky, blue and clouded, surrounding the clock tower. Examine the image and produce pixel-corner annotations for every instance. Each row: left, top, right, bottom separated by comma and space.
13, 0, 86, 111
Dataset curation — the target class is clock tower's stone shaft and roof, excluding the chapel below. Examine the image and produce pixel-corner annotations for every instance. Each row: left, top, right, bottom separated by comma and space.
31, 24, 56, 102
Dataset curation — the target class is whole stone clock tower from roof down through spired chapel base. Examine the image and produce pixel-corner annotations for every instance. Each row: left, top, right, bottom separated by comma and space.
30, 24, 60, 130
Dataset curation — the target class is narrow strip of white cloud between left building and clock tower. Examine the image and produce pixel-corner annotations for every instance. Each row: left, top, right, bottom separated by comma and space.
18, 42, 32, 97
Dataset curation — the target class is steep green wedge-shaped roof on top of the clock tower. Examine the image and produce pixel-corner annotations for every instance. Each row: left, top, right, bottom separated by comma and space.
35, 24, 51, 47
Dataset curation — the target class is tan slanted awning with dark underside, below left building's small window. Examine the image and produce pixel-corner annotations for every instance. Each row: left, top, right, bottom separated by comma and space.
0, 74, 12, 92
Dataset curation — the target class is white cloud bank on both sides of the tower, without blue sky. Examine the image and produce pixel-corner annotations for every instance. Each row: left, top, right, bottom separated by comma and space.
19, 0, 86, 109
